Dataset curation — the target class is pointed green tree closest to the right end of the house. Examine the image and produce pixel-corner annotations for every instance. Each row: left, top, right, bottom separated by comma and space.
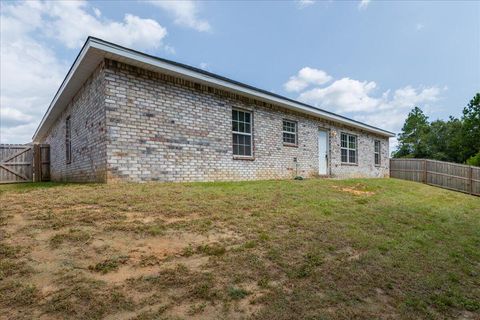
393, 107, 431, 158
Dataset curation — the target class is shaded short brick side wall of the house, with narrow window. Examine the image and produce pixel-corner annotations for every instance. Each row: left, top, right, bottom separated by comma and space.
39, 63, 106, 182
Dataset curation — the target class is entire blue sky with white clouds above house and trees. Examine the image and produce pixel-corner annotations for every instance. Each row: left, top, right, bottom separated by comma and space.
0, 0, 480, 148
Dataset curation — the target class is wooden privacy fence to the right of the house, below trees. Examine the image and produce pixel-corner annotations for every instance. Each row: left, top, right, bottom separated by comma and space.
390, 159, 480, 196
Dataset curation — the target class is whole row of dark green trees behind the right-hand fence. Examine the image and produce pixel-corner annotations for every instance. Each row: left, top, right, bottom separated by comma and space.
392, 93, 480, 166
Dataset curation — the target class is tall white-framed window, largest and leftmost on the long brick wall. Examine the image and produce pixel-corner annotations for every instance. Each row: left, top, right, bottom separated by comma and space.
232, 110, 252, 157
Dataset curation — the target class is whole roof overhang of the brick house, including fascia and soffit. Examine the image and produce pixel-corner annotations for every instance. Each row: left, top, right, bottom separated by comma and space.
33, 37, 395, 141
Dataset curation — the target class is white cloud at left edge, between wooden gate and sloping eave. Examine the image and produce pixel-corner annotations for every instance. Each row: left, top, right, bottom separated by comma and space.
0, 36, 67, 143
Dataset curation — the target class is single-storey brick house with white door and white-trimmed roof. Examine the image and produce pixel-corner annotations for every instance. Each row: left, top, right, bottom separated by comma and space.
33, 37, 394, 182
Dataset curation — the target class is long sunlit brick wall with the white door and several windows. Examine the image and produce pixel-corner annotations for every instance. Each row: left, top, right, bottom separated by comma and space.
104, 60, 389, 181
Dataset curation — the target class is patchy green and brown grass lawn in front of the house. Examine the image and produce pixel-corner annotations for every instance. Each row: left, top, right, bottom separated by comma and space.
0, 179, 480, 319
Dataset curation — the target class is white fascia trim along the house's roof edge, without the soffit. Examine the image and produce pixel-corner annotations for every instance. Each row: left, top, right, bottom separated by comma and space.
33, 36, 395, 140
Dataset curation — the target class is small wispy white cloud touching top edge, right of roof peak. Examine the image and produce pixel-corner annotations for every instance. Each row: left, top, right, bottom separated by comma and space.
147, 0, 211, 31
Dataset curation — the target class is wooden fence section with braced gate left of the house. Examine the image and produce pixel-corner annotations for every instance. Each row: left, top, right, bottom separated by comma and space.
0, 144, 50, 183
